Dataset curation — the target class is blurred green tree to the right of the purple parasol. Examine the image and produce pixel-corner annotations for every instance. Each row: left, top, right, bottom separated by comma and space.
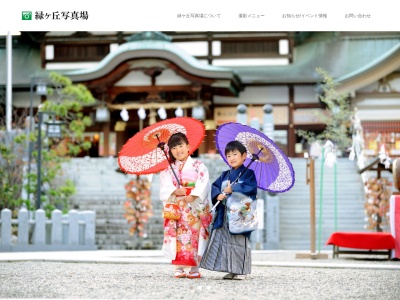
296, 68, 354, 151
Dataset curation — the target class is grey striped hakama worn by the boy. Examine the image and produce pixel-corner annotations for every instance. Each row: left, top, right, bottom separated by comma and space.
200, 214, 251, 275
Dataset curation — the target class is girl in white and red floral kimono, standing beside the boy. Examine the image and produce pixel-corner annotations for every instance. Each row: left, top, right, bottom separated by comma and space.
160, 133, 211, 279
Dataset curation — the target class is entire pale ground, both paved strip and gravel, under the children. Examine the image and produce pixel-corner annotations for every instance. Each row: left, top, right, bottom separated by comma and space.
0, 250, 400, 300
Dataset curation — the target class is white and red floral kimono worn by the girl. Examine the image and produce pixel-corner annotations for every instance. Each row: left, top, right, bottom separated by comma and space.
160, 156, 212, 266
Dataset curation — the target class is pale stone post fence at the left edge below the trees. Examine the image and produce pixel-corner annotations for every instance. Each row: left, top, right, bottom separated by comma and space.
0, 208, 97, 252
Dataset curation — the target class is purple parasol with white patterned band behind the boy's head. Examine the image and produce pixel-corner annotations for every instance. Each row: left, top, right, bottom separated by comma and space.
215, 123, 295, 193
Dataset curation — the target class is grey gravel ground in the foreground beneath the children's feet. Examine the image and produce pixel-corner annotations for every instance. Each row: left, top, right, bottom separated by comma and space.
0, 256, 400, 300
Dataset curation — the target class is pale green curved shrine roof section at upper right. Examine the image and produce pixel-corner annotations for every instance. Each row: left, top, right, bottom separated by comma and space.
235, 34, 400, 84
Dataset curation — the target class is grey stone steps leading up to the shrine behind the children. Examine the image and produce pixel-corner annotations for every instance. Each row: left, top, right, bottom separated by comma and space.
64, 156, 365, 250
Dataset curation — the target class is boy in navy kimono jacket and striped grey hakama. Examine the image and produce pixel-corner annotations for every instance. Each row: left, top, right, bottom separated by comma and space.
200, 141, 257, 280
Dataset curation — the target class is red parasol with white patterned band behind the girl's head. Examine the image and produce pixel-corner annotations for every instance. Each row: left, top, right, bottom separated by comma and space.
118, 117, 205, 175
